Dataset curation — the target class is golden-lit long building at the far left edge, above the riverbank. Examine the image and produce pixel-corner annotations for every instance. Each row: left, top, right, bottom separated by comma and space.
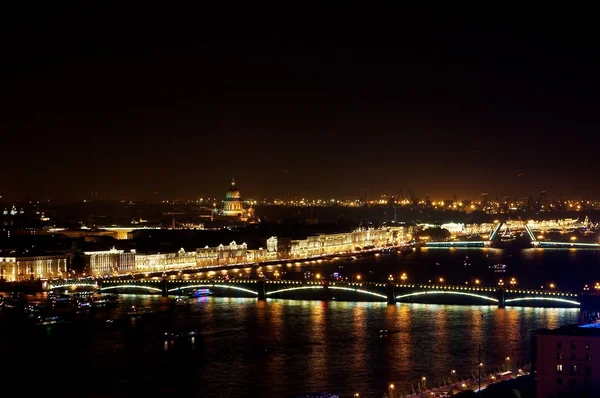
0, 255, 69, 282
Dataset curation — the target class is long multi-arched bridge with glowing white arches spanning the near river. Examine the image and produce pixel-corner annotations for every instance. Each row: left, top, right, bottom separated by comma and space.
55, 279, 583, 308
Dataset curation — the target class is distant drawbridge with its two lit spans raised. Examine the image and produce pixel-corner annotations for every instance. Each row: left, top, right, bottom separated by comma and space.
425, 221, 600, 249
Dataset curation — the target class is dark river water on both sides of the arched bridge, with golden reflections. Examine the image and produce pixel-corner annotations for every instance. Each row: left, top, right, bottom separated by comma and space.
0, 250, 598, 397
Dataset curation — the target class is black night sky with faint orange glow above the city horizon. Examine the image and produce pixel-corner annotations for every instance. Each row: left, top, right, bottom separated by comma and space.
0, 2, 600, 198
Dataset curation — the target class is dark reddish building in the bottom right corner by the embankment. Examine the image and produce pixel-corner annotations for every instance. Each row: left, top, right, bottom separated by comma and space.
534, 325, 600, 398
